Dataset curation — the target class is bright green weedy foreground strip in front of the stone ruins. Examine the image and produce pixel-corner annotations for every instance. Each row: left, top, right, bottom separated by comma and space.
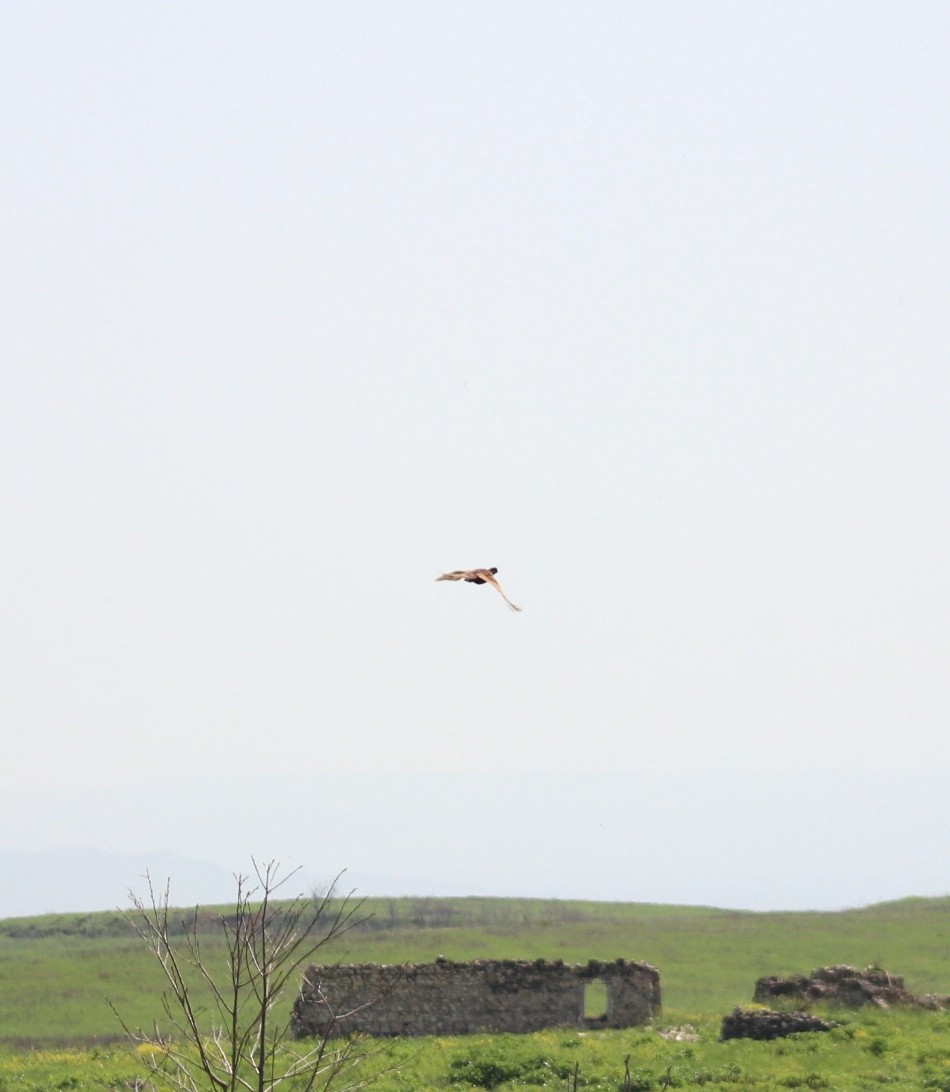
0, 1010, 950, 1092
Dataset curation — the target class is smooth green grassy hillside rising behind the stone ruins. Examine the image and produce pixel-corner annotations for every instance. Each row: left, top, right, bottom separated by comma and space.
0, 898, 950, 1045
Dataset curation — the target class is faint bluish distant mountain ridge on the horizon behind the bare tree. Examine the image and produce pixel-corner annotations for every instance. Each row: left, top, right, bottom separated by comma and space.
0, 848, 425, 918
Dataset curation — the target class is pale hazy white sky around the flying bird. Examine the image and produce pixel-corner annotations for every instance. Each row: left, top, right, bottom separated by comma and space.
0, 0, 950, 909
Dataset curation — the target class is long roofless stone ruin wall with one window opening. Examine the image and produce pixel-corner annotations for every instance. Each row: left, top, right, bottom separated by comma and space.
293, 958, 661, 1037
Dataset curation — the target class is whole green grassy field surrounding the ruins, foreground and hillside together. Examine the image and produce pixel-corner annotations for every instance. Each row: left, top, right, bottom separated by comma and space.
0, 899, 950, 1092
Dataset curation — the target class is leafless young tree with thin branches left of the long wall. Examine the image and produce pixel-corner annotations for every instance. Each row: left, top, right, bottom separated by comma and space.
114, 859, 390, 1092
